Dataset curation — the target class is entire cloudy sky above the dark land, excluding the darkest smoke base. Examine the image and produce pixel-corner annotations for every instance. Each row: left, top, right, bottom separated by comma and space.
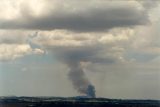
0, 0, 160, 99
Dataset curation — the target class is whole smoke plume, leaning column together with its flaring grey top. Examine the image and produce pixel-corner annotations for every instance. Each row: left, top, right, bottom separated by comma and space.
49, 46, 99, 97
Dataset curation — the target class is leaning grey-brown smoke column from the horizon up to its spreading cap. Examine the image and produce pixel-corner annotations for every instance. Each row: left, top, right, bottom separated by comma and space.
67, 62, 95, 97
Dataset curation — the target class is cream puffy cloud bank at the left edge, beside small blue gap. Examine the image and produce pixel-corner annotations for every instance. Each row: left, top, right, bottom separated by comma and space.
0, 30, 45, 61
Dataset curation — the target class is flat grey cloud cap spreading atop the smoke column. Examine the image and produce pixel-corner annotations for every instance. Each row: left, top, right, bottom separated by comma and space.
48, 45, 118, 64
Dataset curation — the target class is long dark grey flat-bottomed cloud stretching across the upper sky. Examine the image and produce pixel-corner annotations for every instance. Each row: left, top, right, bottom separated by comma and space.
0, 5, 149, 32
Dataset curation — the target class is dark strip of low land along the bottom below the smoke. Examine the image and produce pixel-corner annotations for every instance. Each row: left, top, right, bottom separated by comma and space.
0, 97, 160, 107
